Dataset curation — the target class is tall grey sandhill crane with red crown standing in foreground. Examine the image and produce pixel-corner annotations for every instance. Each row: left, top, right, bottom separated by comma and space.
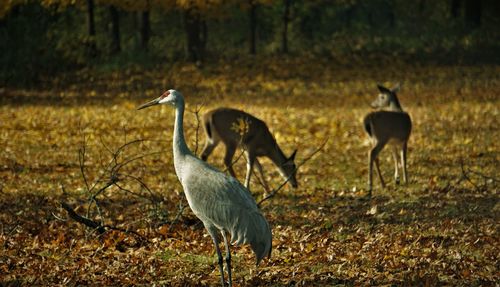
138, 90, 272, 286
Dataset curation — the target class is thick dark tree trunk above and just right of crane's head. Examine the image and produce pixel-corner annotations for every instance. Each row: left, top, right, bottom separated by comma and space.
184, 9, 206, 62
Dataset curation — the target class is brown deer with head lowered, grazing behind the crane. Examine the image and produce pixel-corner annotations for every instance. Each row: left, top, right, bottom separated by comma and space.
201, 108, 297, 191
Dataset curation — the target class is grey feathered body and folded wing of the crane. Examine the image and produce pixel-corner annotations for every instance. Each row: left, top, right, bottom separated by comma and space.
181, 157, 272, 264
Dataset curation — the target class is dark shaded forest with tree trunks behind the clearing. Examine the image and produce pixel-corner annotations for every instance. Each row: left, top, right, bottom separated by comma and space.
0, 0, 500, 86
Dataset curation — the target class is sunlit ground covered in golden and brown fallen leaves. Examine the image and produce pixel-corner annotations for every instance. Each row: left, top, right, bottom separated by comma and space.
0, 59, 500, 286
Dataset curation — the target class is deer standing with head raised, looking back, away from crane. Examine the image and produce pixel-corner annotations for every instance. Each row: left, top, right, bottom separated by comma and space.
363, 84, 411, 195
